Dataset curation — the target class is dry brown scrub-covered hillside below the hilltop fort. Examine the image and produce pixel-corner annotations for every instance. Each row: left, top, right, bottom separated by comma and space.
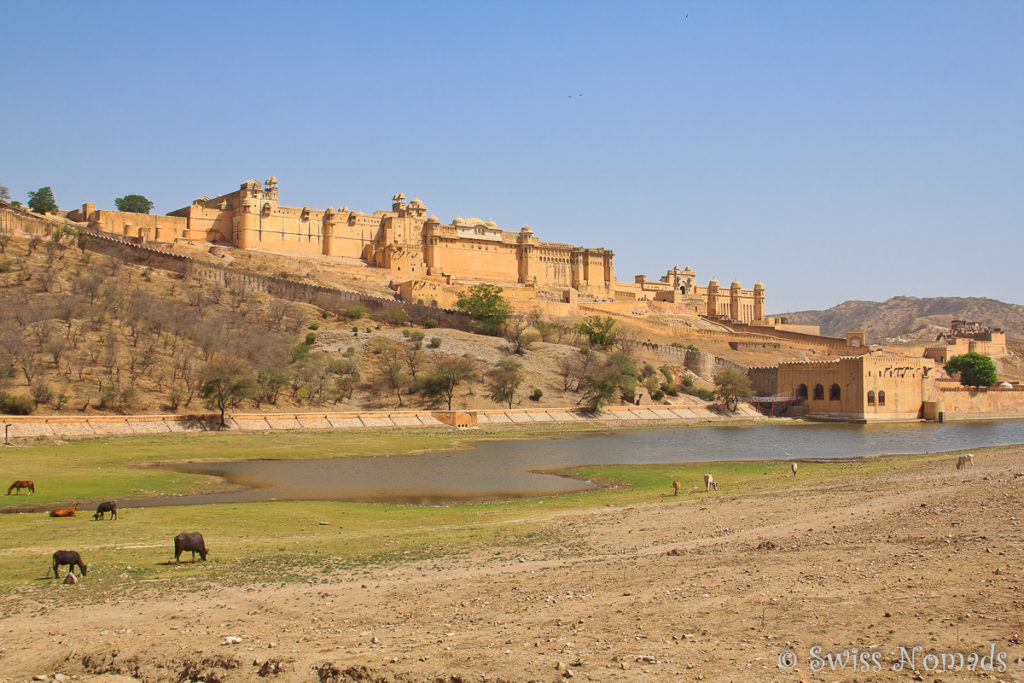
0, 232, 725, 415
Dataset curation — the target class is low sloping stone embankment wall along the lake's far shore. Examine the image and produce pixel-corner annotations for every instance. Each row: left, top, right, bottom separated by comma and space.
0, 404, 762, 443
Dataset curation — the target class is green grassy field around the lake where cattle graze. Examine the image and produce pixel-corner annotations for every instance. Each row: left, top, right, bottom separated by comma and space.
0, 428, 966, 595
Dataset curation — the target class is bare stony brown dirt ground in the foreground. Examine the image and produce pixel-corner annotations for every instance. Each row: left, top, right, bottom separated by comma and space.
0, 449, 1024, 683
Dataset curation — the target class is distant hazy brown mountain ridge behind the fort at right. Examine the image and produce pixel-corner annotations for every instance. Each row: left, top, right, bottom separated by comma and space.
776, 296, 1024, 344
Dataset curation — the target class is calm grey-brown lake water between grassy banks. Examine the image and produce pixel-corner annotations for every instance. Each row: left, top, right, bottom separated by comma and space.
144, 421, 1024, 507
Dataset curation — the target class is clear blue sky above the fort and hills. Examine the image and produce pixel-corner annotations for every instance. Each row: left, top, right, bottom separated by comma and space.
0, 0, 1024, 312
